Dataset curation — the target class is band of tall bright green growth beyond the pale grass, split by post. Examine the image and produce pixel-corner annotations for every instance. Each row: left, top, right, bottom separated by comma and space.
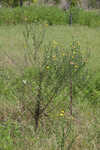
0, 5, 100, 27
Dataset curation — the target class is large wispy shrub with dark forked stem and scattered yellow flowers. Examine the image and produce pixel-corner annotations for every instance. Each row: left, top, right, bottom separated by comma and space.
1, 23, 88, 130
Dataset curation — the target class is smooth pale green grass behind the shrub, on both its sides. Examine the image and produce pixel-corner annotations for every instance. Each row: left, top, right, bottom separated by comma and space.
0, 25, 100, 71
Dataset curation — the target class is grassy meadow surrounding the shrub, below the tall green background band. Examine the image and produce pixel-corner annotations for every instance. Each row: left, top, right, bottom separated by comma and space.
0, 24, 100, 150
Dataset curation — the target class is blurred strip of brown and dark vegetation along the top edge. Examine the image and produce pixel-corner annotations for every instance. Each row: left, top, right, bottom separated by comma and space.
0, 0, 100, 8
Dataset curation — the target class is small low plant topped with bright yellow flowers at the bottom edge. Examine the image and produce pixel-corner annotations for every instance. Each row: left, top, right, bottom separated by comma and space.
54, 116, 77, 150
